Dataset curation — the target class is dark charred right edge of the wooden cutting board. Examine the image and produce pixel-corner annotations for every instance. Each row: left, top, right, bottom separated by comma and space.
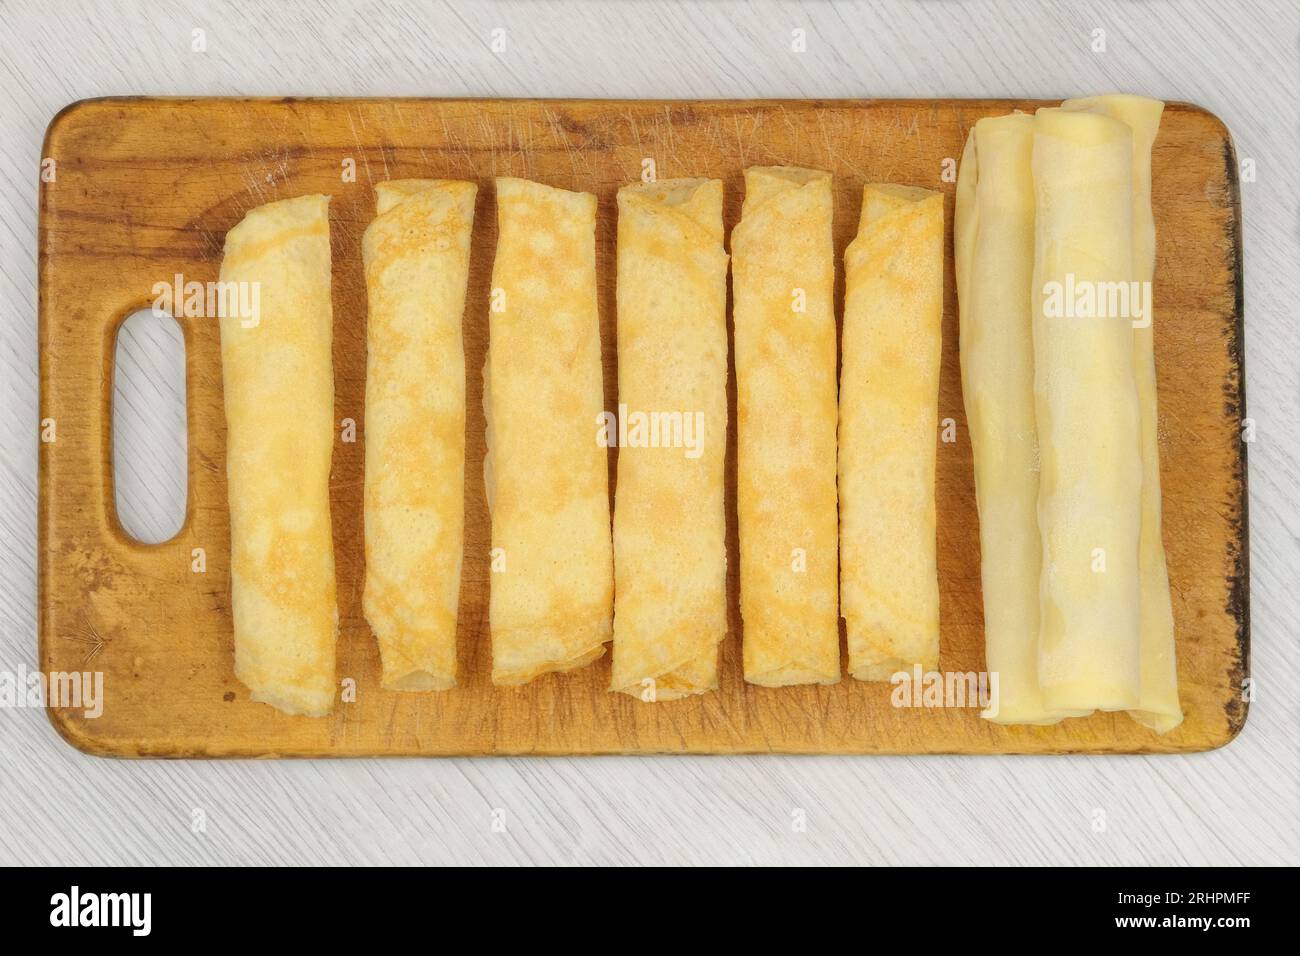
1223, 127, 1251, 744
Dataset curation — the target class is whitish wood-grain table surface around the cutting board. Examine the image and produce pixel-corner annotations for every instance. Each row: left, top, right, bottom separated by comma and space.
0, 0, 1300, 864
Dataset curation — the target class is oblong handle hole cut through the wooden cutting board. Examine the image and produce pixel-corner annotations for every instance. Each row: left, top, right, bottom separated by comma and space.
112, 308, 190, 545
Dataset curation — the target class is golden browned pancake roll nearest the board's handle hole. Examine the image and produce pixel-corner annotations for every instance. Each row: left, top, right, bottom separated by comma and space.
221, 195, 338, 715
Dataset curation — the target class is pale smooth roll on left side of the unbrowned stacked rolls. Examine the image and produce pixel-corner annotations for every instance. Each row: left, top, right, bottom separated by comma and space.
953, 113, 1063, 723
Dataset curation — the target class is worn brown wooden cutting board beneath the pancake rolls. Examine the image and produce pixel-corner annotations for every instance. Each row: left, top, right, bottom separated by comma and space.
39, 99, 1249, 757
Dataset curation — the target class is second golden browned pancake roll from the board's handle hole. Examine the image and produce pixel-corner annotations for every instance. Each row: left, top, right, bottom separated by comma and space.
361, 179, 477, 691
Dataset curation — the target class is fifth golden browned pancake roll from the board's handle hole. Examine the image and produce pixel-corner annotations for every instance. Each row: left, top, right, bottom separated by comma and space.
732, 166, 840, 687
